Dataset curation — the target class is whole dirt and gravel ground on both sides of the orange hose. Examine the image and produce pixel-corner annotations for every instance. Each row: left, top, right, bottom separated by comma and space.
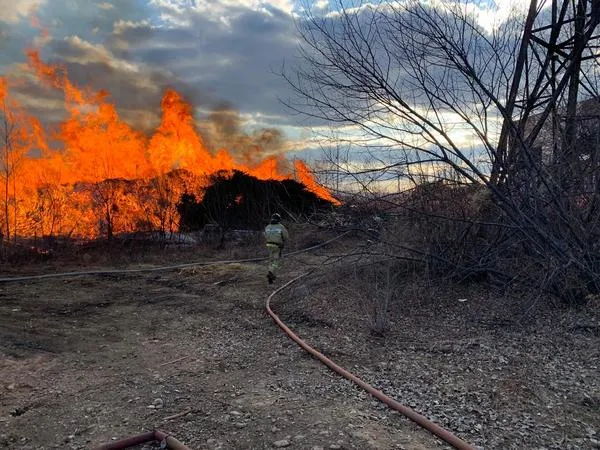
0, 234, 600, 450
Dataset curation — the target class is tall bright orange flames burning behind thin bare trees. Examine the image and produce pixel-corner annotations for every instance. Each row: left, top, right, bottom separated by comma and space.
0, 50, 337, 238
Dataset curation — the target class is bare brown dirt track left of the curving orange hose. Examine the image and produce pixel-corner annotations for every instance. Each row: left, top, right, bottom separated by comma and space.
0, 255, 437, 449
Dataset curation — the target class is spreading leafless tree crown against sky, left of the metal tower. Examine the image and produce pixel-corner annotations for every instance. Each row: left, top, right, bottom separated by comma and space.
288, 1, 519, 182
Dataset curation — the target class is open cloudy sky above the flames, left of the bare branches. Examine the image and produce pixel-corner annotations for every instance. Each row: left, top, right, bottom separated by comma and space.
0, 0, 536, 167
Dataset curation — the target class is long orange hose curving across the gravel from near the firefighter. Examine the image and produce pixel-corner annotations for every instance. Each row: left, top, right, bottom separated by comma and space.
266, 272, 474, 450
